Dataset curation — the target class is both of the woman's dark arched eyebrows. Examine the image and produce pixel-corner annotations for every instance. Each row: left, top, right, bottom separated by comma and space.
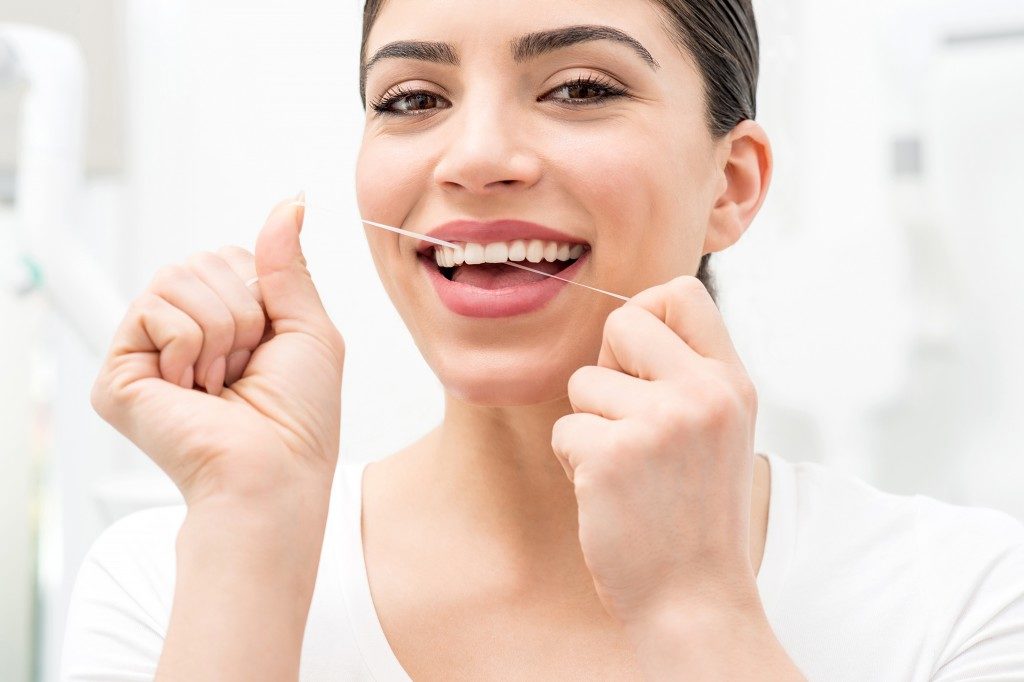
359, 26, 662, 85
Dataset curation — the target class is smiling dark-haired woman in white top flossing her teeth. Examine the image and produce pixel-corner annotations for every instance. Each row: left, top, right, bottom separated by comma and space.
63, 0, 1024, 680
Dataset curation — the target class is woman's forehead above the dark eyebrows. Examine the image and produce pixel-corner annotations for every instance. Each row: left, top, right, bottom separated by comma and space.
366, 0, 680, 62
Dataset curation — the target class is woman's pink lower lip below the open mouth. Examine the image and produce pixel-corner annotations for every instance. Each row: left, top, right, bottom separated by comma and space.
418, 250, 590, 317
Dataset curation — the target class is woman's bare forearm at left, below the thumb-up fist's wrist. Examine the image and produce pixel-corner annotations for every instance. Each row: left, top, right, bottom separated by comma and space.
156, 491, 327, 682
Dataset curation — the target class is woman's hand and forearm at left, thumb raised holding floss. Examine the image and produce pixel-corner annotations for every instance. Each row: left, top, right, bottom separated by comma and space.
91, 202, 345, 682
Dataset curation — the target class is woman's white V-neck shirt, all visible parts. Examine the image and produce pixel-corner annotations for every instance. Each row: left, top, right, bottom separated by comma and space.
60, 453, 1024, 682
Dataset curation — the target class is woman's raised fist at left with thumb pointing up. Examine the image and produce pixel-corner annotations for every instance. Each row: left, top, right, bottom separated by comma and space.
91, 195, 345, 506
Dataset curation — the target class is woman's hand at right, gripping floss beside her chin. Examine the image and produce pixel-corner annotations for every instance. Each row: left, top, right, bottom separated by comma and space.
552, 276, 760, 629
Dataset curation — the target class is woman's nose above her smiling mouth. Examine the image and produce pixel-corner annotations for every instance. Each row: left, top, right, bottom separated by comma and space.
434, 94, 541, 195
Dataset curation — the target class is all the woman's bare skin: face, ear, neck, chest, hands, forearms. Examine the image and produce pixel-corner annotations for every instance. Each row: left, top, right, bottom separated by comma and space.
92, 0, 803, 680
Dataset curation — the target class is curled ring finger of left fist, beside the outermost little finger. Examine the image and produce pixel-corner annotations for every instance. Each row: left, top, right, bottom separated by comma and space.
151, 265, 234, 392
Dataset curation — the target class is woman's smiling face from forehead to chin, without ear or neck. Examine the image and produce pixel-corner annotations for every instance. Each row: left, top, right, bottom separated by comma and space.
356, 0, 723, 406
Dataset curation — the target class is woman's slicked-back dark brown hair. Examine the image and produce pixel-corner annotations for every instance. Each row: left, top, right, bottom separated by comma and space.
359, 0, 760, 298
